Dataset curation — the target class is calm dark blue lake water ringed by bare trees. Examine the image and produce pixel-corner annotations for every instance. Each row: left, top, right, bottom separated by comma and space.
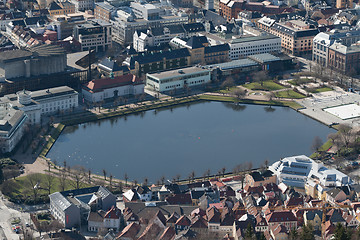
47, 102, 334, 183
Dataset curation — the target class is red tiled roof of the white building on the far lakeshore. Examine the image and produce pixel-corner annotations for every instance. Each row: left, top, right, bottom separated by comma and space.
83, 74, 143, 92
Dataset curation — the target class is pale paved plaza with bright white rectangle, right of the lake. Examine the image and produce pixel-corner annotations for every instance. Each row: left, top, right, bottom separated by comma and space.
297, 88, 360, 127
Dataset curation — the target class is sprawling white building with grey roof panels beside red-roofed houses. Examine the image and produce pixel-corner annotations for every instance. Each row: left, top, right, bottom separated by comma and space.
269, 155, 352, 188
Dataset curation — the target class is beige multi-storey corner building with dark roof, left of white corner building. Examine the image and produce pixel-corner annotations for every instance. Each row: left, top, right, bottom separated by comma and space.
257, 17, 319, 55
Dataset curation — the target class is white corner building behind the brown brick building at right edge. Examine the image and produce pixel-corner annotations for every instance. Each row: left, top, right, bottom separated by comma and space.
312, 30, 360, 67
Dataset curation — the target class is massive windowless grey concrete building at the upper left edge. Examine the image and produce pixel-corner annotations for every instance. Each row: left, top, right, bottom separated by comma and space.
0, 45, 67, 81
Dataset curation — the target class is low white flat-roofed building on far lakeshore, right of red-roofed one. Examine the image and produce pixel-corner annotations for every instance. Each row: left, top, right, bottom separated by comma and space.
146, 66, 211, 92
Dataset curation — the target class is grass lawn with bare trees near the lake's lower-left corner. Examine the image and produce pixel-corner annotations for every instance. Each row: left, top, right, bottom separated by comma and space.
3, 173, 91, 201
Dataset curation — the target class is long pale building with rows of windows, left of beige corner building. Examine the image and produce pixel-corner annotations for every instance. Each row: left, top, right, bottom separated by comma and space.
229, 34, 281, 60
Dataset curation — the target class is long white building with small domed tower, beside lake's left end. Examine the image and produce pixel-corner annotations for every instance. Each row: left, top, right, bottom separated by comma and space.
1, 86, 78, 124
